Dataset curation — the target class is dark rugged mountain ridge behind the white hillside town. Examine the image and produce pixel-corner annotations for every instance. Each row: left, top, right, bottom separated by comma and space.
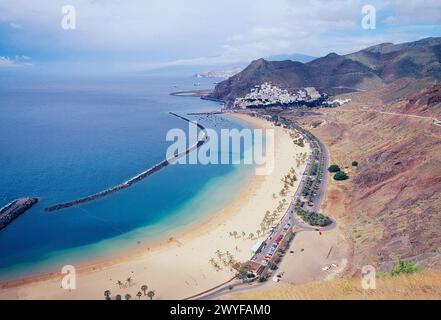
211, 38, 441, 106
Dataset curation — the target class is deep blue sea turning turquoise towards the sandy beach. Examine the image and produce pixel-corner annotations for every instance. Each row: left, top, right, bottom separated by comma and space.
0, 76, 253, 280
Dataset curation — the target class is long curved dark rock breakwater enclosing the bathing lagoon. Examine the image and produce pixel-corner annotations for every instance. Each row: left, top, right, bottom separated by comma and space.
45, 112, 208, 212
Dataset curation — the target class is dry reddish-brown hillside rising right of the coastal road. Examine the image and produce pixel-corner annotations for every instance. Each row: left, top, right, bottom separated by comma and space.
282, 82, 441, 273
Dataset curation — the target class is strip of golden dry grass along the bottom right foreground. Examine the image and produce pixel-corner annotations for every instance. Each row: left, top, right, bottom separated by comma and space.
222, 272, 441, 300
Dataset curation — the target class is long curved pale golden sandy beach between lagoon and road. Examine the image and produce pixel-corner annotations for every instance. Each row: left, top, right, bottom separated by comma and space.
0, 114, 308, 299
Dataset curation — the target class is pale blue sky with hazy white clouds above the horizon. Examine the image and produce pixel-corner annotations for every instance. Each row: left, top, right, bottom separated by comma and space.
0, 0, 441, 73
